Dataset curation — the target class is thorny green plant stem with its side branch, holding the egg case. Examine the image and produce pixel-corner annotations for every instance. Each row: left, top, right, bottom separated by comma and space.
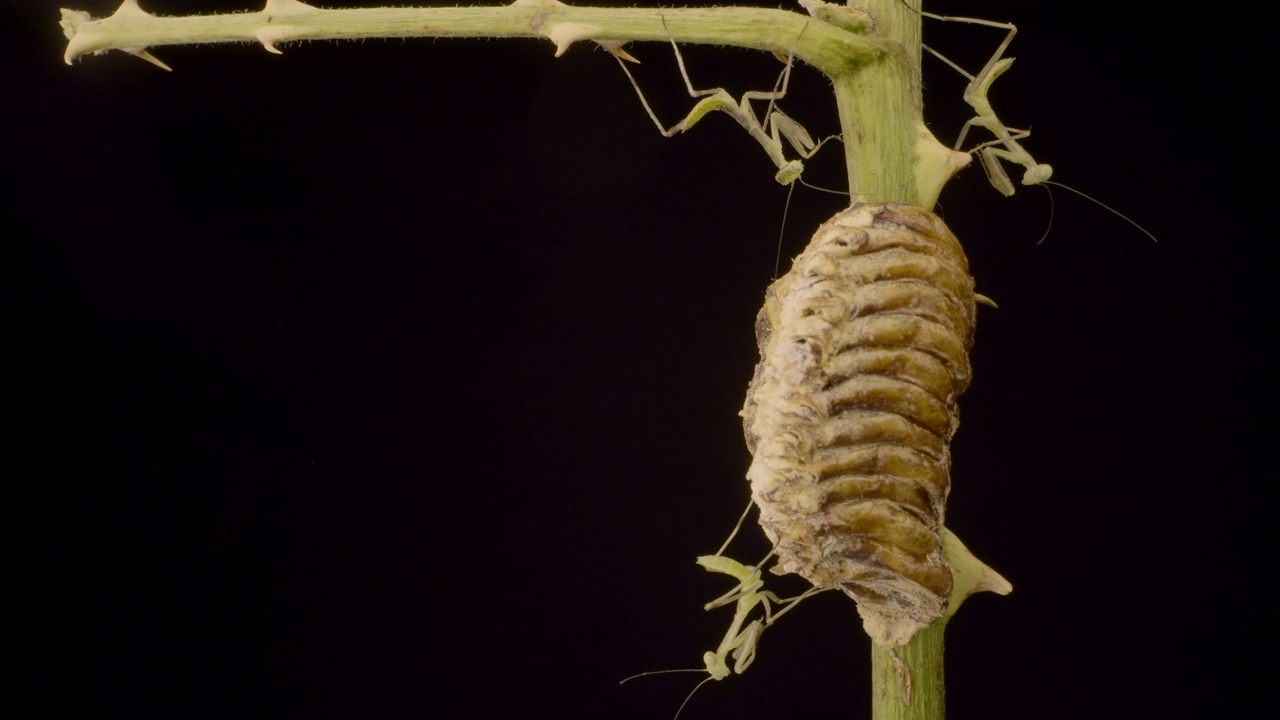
63, 0, 977, 720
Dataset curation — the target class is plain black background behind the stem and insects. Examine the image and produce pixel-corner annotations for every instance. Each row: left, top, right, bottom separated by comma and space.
0, 0, 1275, 720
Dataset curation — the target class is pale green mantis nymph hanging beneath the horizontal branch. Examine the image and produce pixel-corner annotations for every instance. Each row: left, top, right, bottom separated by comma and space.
614, 18, 838, 184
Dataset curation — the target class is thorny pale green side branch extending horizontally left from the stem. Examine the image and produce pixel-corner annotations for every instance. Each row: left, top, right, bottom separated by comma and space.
61, 0, 884, 77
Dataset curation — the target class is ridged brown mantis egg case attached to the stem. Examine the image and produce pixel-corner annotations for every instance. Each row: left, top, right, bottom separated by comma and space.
742, 204, 974, 647
